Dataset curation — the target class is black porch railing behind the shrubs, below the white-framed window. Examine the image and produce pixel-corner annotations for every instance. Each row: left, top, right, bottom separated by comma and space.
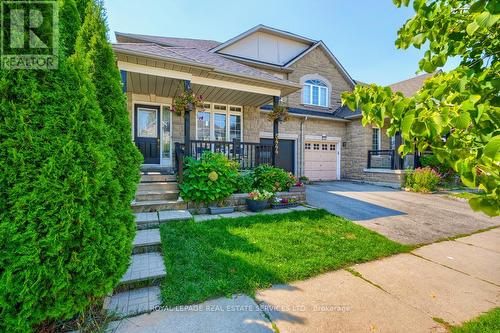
175, 140, 273, 176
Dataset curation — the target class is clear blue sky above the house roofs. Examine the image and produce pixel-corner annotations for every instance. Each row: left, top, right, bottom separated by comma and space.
104, 0, 458, 85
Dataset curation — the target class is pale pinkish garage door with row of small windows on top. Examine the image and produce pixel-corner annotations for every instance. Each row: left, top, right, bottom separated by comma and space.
304, 141, 338, 180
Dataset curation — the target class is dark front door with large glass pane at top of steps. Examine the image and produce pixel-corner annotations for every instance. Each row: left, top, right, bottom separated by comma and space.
134, 105, 160, 164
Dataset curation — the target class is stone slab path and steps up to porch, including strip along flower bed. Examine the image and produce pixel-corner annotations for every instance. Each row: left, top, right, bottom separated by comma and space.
104, 173, 310, 317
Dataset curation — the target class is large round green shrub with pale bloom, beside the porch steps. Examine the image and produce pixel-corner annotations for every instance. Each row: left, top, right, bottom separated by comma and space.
179, 152, 238, 204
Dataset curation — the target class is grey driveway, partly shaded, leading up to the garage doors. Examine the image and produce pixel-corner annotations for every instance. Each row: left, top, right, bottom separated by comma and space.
307, 181, 500, 244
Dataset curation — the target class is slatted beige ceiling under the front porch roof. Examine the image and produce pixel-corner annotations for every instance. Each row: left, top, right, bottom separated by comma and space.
127, 72, 272, 106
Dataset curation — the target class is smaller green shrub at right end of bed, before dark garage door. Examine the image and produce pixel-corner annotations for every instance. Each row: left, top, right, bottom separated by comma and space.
253, 164, 296, 192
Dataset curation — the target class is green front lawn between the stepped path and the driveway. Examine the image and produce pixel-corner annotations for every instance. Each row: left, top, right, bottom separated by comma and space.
161, 210, 409, 306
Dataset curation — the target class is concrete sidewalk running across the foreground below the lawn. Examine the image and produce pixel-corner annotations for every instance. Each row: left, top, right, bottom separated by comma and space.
108, 229, 500, 333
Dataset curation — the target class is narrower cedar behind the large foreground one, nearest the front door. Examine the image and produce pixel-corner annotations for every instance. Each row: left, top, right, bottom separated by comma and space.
75, 0, 143, 211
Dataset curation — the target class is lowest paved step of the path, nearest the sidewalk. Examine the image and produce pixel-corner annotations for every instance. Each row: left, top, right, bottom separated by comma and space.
104, 286, 161, 316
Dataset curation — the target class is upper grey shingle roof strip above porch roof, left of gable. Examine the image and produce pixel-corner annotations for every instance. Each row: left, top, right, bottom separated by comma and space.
115, 32, 221, 51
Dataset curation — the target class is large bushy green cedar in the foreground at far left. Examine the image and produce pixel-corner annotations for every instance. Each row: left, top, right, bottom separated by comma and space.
0, 0, 139, 332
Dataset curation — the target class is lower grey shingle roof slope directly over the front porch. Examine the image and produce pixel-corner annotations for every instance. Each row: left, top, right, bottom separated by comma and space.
113, 43, 296, 86
